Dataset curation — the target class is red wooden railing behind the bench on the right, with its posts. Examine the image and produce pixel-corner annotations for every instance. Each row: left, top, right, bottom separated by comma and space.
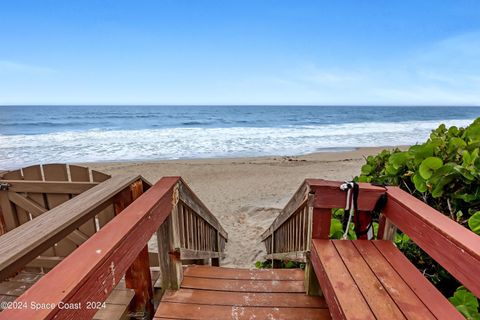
262, 179, 480, 296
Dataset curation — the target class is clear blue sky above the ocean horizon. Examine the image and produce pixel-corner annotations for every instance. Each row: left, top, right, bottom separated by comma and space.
0, 0, 480, 105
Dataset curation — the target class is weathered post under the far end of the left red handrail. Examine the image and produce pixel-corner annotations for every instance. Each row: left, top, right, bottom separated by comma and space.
157, 184, 183, 290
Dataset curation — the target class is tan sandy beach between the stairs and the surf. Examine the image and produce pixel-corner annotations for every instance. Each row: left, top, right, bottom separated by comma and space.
88, 148, 402, 267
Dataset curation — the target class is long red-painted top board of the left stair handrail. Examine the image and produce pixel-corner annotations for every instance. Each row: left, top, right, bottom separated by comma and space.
0, 176, 179, 320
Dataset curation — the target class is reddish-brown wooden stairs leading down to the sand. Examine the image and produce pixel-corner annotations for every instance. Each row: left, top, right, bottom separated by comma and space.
155, 266, 330, 320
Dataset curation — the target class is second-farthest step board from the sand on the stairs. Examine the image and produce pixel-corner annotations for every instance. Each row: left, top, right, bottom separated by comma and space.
181, 276, 305, 293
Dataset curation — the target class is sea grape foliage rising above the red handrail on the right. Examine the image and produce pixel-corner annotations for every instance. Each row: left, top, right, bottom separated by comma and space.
357, 118, 480, 230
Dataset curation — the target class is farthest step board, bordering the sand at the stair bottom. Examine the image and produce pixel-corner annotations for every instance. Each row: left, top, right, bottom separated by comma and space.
183, 265, 303, 281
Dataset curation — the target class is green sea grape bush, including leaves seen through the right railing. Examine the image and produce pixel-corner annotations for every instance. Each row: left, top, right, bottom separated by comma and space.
354, 118, 480, 319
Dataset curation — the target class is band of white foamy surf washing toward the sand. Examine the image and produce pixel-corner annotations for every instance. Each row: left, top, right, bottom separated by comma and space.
0, 119, 473, 169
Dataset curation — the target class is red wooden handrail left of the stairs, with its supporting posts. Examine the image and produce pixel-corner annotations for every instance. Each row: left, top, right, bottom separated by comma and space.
0, 177, 227, 319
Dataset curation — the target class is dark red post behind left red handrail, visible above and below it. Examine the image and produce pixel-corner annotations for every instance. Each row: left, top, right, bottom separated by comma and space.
114, 180, 154, 319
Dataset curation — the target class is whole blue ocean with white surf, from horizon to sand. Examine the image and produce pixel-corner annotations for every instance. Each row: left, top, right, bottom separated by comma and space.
0, 106, 480, 169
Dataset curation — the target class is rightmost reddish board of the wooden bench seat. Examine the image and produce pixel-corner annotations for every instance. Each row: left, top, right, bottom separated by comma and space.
372, 241, 463, 320
